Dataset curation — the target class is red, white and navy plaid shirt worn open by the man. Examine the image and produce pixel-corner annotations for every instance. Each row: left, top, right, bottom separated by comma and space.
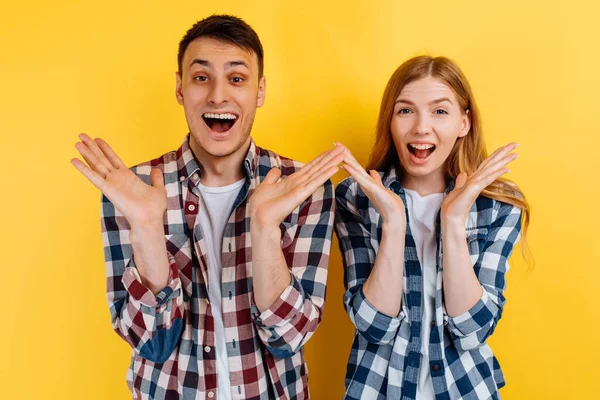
102, 137, 334, 400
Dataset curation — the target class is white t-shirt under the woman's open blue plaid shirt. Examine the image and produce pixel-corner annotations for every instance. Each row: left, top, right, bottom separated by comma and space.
404, 189, 445, 400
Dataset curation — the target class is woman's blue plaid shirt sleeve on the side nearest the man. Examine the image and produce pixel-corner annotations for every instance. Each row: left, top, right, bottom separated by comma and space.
335, 178, 406, 344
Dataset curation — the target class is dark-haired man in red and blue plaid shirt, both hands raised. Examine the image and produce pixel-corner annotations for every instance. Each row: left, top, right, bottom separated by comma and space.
72, 15, 343, 399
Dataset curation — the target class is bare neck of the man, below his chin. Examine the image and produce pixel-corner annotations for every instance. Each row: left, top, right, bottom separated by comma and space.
190, 136, 250, 187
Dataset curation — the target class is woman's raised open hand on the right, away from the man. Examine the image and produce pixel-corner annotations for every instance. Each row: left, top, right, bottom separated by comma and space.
442, 143, 519, 228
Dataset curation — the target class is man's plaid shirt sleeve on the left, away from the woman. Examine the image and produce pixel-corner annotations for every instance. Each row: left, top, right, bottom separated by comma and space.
101, 192, 184, 363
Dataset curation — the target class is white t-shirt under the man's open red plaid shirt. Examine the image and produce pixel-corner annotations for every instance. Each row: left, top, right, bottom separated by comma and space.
198, 179, 244, 400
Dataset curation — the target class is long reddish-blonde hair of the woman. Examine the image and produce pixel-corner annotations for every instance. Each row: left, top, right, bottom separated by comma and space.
367, 56, 532, 265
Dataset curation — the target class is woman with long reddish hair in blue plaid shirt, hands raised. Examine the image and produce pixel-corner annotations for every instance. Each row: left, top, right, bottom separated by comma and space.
336, 56, 529, 399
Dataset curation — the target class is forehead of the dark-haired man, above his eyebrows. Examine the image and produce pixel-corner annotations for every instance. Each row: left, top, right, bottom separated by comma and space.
182, 37, 258, 70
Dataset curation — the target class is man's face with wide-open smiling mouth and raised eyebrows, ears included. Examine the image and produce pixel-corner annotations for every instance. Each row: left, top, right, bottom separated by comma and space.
176, 38, 265, 157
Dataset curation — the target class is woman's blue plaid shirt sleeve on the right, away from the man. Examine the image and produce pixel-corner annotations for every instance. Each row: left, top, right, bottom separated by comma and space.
444, 203, 522, 351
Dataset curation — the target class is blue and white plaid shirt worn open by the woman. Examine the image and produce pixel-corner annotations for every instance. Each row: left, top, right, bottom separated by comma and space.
336, 169, 521, 400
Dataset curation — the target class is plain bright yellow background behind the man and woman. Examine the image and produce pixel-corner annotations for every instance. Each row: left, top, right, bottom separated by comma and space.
0, 0, 600, 400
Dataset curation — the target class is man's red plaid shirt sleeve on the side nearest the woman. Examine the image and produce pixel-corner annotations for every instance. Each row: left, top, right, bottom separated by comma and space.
251, 180, 335, 358
